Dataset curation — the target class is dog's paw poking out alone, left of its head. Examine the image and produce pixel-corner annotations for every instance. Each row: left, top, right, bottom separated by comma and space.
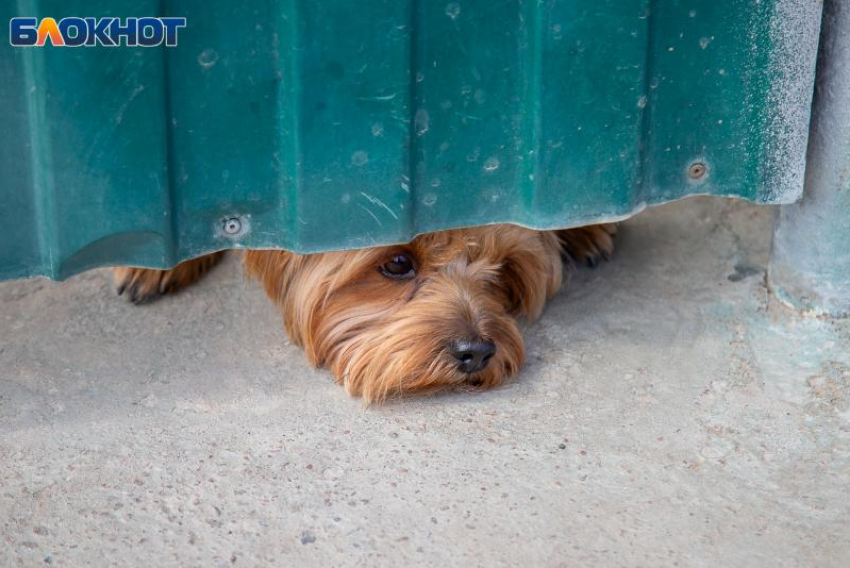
112, 252, 224, 304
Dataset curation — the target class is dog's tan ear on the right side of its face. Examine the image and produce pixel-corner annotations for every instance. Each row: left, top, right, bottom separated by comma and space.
501, 233, 564, 320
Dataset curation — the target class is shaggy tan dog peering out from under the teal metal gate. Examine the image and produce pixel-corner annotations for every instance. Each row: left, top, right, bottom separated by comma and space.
114, 224, 616, 405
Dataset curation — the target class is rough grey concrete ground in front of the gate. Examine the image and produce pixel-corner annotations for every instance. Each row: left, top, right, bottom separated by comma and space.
0, 199, 850, 567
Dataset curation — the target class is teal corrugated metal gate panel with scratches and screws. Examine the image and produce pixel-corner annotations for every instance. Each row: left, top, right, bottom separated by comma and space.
0, 0, 821, 279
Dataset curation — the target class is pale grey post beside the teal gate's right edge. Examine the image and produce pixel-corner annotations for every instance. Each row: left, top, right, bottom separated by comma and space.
769, 0, 850, 316
